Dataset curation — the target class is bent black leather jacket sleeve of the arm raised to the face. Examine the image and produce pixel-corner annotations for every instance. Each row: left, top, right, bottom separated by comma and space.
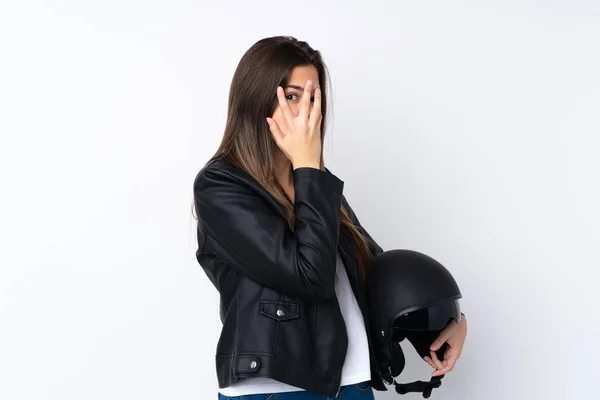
194, 168, 344, 299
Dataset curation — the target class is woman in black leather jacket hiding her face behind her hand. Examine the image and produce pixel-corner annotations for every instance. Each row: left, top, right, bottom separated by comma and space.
194, 37, 464, 400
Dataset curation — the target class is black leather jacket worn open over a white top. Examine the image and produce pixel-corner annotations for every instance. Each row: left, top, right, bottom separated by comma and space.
194, 159, 385, 397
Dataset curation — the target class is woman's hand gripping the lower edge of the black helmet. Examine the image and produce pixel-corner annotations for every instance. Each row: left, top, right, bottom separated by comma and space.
424, 315, 467, 376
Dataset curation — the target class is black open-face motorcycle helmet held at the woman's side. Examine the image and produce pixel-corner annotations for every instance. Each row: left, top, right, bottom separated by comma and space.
369, 250, 462, 398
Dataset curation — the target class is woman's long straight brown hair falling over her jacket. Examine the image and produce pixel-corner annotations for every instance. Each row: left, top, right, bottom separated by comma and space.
195, 36, 371, 279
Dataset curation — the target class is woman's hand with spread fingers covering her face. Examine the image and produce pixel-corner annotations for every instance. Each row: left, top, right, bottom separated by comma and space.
267, 80, 322, 169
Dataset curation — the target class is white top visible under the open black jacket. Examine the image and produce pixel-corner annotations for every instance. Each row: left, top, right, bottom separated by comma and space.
219, 254, 371, 397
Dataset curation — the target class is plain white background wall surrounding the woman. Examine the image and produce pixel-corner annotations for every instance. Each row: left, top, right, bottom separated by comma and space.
0, 0, 600, 400
